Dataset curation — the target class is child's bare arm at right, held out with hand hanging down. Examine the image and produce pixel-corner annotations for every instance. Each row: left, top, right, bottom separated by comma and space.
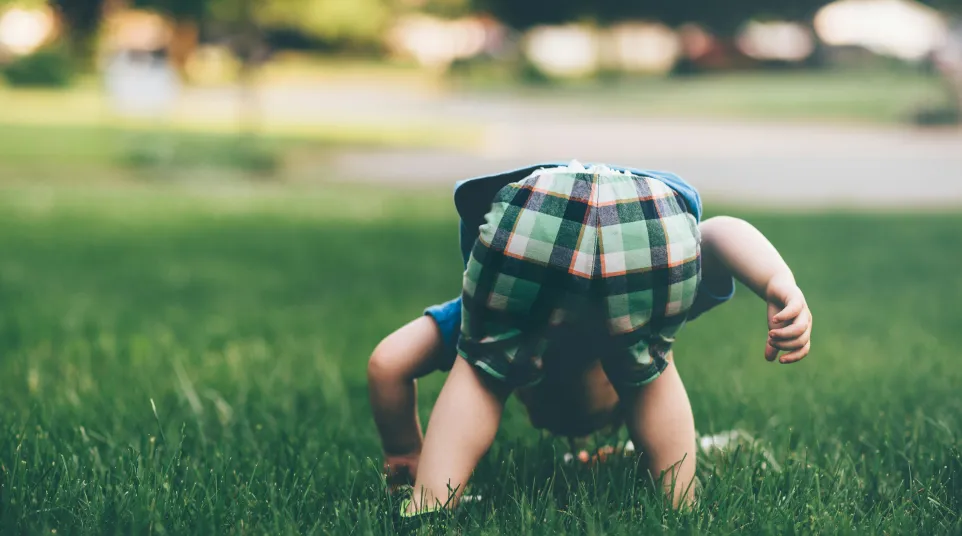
700, 216, 812, 363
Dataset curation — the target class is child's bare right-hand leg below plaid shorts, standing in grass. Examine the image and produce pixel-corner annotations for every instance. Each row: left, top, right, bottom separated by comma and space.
622, 362, 695, 508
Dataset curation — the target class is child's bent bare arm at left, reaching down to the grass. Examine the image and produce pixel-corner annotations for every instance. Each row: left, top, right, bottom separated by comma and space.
367, 316, 441, 480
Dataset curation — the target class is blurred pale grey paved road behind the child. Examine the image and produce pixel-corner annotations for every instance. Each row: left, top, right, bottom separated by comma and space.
191, 86, 962, 207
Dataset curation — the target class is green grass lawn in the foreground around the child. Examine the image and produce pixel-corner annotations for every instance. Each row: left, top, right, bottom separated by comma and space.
0, 184, 962, 535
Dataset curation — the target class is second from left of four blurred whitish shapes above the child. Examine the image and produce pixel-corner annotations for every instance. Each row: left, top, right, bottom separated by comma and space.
523, 24, 601, 77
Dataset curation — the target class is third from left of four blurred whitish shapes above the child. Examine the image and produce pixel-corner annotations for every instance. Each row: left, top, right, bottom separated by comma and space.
601, 22, 681, 74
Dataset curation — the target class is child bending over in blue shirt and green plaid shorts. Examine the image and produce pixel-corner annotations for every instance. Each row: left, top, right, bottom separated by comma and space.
368, 163, 812, 515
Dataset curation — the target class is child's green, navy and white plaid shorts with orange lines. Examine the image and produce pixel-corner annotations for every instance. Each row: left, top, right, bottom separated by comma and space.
458, 168, 701, 387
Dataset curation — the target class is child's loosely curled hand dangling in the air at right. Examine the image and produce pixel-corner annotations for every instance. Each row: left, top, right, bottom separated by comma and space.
765, 277, 812, 363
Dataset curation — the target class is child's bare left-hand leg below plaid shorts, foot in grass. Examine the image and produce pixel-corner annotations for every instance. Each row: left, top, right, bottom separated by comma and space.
408, 359, 510, 514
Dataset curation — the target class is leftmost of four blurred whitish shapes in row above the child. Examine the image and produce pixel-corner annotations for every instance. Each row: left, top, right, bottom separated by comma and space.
388, 15, 503, 68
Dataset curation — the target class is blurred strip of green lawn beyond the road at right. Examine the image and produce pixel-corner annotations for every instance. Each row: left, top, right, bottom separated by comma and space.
456, 69, 949, 124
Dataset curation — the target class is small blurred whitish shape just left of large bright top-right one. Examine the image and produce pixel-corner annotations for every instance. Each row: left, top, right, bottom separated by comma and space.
737, 21, 815, 62
